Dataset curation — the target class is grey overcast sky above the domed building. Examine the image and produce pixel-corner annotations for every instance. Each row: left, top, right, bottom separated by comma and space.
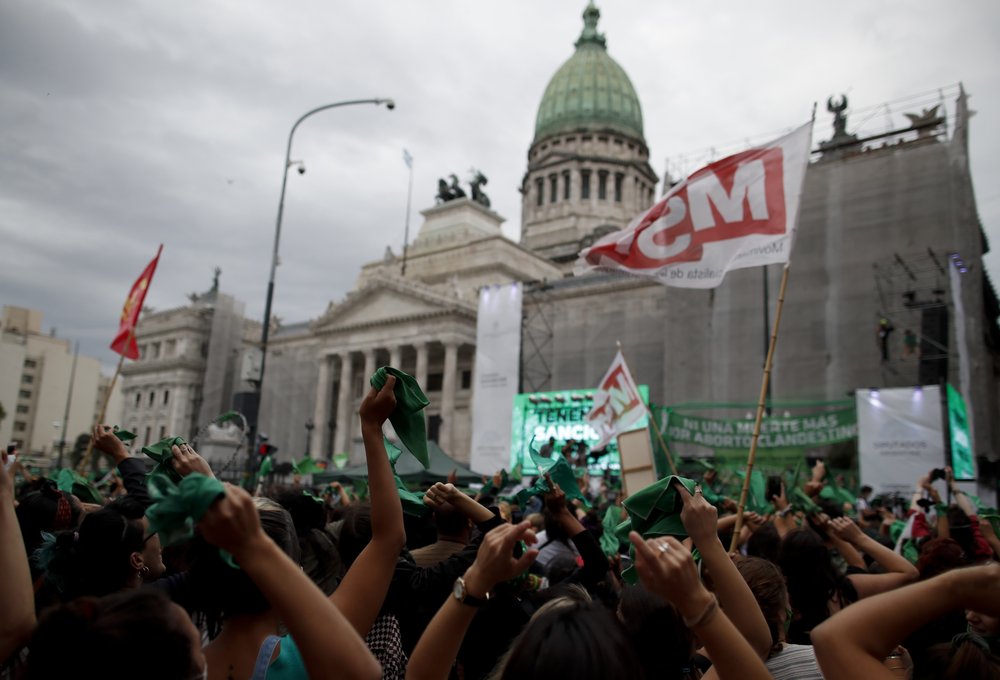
0, 0, 1000, 372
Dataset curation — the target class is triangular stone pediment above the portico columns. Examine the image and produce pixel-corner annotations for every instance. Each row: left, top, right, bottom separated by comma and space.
312, 276, 476, 333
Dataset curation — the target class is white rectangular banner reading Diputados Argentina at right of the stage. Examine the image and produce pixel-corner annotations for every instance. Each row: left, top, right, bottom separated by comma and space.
856, 385, 945, 496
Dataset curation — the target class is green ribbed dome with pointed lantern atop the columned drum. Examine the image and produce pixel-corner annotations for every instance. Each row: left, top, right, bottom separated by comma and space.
535, 2, 643, 142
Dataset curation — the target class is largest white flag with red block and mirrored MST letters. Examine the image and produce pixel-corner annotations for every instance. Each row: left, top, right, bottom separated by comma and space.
576, 122, 812, 288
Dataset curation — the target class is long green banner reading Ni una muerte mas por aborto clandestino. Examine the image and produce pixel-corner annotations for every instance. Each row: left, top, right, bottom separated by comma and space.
664, 409, 858, 449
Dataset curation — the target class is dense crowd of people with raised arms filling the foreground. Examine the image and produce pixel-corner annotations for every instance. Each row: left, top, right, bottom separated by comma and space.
0, 376, 1000, 680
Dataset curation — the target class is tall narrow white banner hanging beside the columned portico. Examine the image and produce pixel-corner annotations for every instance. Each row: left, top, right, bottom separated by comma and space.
469, 283, 521, 474
